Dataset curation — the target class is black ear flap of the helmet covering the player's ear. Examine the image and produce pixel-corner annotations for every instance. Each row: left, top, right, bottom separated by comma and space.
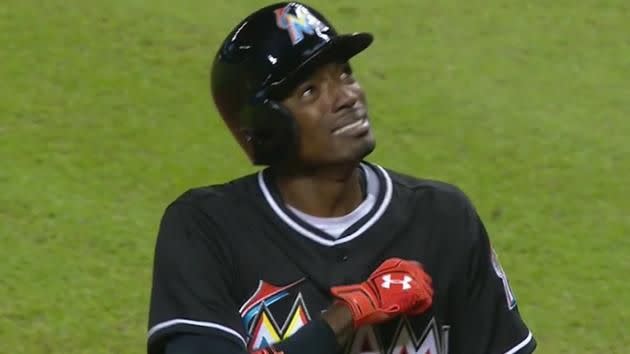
247, 100, 298, 165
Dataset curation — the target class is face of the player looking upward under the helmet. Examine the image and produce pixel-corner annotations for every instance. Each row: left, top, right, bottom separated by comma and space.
283, 63, 375, 166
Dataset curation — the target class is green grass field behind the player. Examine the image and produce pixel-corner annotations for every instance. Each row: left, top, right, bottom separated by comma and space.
0, 0, 630, 354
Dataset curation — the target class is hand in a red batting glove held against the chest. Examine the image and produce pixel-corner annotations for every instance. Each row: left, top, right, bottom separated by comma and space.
330, 258, 433, 328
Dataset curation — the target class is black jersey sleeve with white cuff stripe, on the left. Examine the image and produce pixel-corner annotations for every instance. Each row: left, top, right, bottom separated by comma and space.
147, 202, 245, 354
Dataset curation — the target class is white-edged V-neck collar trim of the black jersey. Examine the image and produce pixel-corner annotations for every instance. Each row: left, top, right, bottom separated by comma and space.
258, 164, 393, 246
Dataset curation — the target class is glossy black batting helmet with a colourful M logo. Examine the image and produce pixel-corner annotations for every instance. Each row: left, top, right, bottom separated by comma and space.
211, 2, 373, 165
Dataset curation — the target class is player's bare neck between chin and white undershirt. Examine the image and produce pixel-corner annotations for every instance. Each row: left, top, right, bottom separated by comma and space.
275, 164, 364, 217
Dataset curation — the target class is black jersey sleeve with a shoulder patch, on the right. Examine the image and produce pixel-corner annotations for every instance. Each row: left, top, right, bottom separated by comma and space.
449, 205, 536, 354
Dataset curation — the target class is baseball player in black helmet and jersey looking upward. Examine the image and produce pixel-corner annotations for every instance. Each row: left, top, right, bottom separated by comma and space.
147, 2, 536, 354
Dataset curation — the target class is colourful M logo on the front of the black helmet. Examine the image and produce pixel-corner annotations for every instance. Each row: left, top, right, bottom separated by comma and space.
275, 4, 329, 45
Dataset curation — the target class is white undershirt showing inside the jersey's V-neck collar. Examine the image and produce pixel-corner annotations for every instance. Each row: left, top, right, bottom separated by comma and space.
287, 165, 380, 238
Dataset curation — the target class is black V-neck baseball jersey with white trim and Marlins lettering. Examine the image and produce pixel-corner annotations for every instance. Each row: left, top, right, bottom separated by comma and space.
148, 163, 536, 354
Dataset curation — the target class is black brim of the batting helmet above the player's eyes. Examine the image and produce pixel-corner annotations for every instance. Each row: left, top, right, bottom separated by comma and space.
268, 32, 374, 99
